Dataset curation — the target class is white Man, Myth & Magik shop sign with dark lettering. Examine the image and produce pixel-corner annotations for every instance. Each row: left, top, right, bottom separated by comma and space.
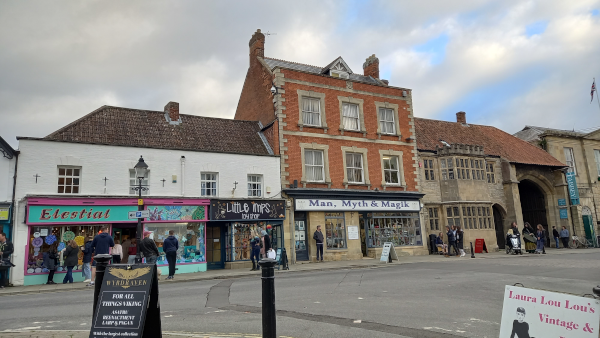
296, 199, 421, 211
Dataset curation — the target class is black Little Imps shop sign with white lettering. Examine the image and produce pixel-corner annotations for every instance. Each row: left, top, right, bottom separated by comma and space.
210, 200, 285, 221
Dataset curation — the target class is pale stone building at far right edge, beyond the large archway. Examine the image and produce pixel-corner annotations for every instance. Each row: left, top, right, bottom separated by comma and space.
514, 126, 600, 244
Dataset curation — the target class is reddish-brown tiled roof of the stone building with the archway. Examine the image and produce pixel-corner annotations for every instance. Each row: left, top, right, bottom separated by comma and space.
415, 118, 565, 167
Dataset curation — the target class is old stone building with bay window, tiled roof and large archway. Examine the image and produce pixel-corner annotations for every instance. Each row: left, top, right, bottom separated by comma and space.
415, 112, 570, 250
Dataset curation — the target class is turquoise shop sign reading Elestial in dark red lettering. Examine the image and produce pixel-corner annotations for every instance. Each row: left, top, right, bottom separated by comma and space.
27, 205, 137, 224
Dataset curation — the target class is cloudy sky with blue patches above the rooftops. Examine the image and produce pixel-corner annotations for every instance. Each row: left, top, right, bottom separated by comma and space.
0, 0, 600, 147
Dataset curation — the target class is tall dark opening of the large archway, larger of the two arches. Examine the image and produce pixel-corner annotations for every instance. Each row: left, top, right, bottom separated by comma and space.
519, 180, 550, 245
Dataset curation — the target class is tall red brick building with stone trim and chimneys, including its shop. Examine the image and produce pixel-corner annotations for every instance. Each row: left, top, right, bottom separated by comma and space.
235, 30, 427, 261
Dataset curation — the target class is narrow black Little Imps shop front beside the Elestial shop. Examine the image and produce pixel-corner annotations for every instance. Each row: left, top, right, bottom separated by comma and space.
206, 199, 285, 269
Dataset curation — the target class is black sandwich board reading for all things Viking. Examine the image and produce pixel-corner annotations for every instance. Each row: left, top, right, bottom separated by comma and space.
89, 264, 162, 338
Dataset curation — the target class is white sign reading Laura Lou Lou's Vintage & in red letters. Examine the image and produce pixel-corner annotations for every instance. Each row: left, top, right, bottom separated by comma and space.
500, 285, 600, 338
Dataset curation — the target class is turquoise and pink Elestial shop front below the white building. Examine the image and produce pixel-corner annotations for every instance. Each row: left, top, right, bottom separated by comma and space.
23, 198, 209, 285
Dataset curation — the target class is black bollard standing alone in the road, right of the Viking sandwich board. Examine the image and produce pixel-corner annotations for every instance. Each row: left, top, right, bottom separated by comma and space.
259, 258, 277, 338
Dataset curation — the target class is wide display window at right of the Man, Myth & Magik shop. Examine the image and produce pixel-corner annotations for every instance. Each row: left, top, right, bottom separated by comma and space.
368, 212, 422, 247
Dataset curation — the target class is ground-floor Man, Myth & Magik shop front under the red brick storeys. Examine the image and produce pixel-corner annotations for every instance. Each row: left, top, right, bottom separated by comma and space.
285, 188, 427, 261
